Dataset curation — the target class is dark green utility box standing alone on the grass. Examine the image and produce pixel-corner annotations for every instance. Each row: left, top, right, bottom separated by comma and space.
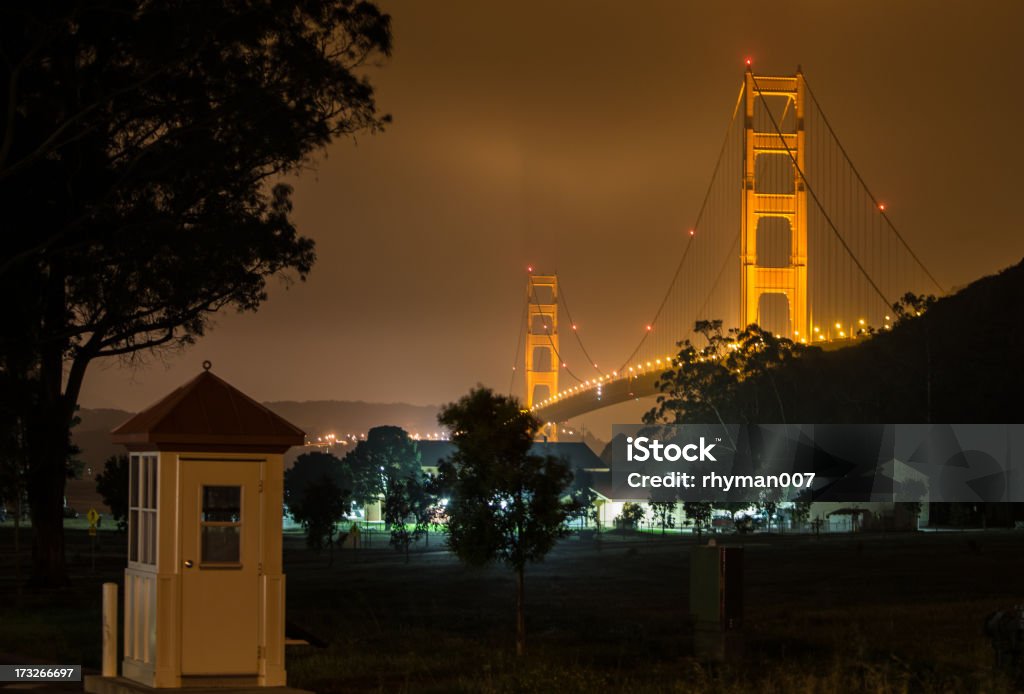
690, 540, 743, 660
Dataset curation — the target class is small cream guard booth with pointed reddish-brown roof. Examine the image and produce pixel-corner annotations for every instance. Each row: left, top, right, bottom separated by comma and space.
113, 362, 305, 688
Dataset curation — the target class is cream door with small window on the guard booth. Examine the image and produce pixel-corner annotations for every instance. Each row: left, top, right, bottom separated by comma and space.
180, 460, 263, 676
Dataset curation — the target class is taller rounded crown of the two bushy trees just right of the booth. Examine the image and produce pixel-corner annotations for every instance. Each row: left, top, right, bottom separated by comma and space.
344, 426, 421, 504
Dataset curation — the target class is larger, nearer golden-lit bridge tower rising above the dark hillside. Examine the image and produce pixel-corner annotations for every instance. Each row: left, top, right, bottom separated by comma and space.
739, 68, 808, 339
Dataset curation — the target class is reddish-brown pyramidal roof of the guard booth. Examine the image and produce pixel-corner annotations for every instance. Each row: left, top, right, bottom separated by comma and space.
111, 371, 305, 452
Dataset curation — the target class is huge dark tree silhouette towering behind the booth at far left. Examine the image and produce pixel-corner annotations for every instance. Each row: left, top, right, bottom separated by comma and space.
0, 0, 391, 584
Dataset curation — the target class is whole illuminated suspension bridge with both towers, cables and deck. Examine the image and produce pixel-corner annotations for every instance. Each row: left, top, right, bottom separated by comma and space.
510, 61, 943, 439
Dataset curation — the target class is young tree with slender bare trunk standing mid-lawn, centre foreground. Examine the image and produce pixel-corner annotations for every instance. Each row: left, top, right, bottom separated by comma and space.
437, 386, 572, 655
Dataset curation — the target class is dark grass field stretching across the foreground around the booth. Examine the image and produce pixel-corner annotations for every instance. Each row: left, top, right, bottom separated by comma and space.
0, 528, 1024, 694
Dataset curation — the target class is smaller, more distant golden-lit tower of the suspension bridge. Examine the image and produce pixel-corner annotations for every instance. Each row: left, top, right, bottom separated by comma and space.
526, 274, 561, 441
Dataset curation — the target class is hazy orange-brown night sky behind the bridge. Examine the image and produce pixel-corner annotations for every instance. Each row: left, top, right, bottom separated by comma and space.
82, 0, 1024, 434
